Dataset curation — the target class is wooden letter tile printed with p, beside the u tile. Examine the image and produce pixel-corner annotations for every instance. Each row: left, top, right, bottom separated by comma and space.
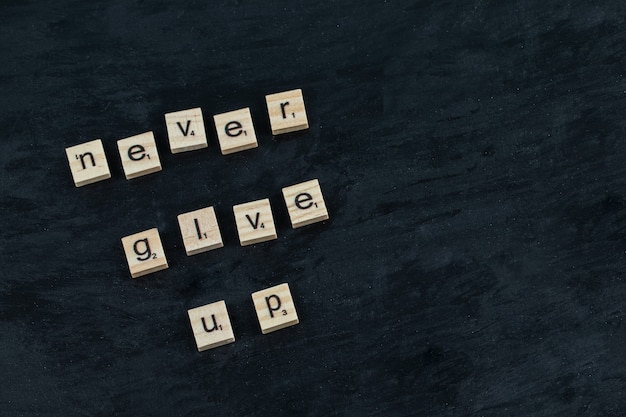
252, 283, 299, 334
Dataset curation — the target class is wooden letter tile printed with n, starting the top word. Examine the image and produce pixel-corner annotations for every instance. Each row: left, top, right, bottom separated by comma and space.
65, 139, 111, 187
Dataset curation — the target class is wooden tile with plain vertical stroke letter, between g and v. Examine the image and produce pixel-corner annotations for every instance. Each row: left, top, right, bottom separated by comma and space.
178, 207, 224, 256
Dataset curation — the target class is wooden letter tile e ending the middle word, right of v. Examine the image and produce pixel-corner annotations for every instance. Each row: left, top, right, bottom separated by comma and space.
283, 180, 328, 229
